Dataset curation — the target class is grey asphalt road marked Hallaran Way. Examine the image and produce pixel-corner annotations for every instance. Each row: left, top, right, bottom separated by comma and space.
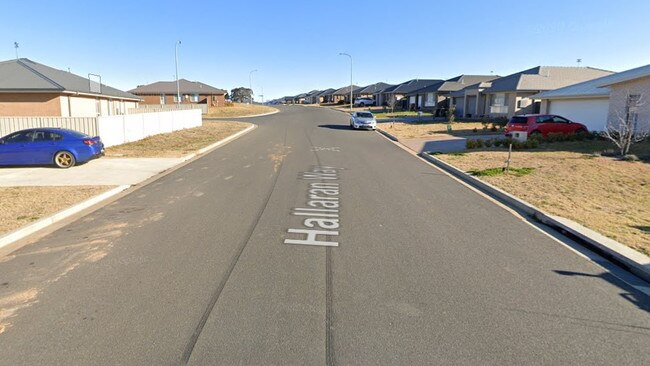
0, 106, 650, 365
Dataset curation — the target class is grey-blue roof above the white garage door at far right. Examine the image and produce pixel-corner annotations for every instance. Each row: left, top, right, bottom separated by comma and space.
532, 65, 650, 99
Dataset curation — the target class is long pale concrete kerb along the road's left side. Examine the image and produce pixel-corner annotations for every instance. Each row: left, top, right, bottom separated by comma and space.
0, 124, 257, 250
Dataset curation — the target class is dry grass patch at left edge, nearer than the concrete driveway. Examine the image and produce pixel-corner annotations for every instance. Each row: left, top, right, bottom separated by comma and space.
0, 186, 113, 235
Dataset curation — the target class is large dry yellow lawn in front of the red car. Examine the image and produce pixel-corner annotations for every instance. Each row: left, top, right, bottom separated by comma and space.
437, 151, 650, 255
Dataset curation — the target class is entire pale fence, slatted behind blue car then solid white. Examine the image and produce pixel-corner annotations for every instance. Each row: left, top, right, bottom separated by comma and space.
0, 109, 202, 146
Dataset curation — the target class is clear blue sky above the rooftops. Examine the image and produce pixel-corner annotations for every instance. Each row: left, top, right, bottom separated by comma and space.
0, 0, 650, 100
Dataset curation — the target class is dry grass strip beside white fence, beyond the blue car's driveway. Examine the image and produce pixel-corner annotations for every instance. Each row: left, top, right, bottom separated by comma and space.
106, 121, 250, 158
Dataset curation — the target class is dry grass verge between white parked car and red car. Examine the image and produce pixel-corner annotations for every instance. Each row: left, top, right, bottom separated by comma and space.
379, 122, 503, 140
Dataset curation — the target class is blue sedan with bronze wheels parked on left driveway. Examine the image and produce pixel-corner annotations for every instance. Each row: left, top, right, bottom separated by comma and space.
0, 128, 104, 168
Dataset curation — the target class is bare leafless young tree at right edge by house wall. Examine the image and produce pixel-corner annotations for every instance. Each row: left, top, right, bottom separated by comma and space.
602, 92, 650, 156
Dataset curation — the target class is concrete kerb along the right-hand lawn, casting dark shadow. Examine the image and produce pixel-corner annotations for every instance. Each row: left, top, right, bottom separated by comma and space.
420, 152, 650, 282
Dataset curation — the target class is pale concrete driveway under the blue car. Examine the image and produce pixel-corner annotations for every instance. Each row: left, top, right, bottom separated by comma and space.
0, 158, 185, 187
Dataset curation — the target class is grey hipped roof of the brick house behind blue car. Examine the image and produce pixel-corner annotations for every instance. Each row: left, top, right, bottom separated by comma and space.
0, 58, 141, 100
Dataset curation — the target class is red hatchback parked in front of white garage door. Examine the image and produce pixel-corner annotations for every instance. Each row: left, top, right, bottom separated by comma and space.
505, 114, 589, 137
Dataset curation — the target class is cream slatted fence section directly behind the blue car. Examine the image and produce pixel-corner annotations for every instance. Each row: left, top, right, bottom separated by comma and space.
0, 117, 99, 137
